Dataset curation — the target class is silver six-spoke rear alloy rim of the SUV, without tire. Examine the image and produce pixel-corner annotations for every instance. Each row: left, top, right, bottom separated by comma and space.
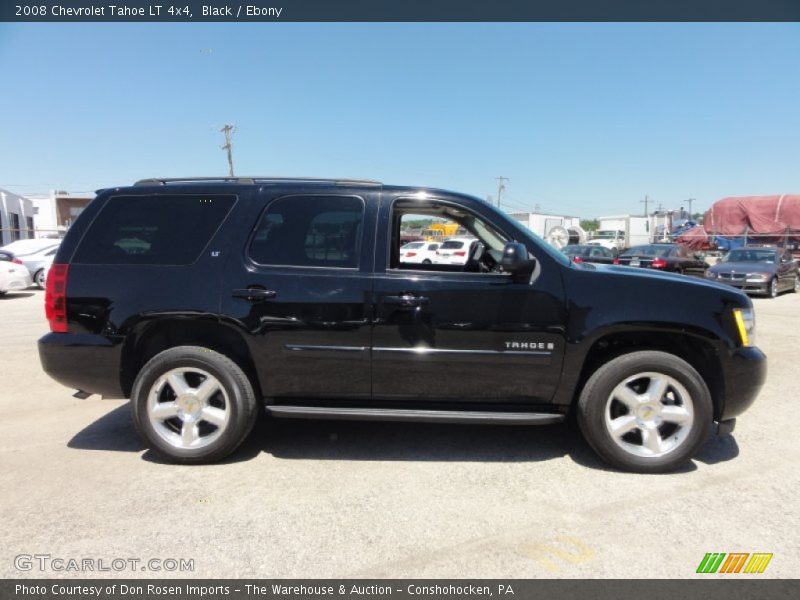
147, 368, 231, 449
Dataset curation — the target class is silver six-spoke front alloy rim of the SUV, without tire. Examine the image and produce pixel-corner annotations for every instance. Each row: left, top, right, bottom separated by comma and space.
605, 372, 694, 458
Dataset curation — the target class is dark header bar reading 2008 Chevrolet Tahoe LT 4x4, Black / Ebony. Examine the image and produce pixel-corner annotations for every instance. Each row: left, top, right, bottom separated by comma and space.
0, 0, 800, 22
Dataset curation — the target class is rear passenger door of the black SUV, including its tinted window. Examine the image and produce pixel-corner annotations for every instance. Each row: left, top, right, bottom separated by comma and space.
222, 188, 377, 400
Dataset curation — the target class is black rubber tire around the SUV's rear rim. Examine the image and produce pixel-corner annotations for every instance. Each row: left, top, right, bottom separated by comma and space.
131, 346, 258, 464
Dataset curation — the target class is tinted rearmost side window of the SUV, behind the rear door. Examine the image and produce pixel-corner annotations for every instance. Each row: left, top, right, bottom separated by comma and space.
73, 194, 236, 265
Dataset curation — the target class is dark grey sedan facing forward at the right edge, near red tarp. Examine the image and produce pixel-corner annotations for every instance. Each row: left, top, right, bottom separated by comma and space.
706, 246, 800, 298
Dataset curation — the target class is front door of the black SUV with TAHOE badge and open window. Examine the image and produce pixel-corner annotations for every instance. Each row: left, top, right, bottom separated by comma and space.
372, 197, 565, 403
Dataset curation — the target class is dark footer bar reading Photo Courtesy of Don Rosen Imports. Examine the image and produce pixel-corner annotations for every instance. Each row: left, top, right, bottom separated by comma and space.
0, 576, 800, 600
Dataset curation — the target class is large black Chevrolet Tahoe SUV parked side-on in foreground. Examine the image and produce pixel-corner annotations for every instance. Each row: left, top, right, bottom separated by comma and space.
39, 178, 766, 472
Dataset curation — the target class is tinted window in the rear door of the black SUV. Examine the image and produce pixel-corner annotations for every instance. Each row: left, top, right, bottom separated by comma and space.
249, 196, 364, 268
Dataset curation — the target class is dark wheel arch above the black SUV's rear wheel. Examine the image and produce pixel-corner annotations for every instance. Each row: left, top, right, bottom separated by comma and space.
120, 316, 262, 398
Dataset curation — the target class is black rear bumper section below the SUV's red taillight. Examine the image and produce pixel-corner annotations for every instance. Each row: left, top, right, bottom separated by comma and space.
39, 333, 125, 398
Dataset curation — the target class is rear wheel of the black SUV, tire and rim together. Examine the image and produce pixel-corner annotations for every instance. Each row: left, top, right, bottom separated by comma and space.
131, 346, 257, 463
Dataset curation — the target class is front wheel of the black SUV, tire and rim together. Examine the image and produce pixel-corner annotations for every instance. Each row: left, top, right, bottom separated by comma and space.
577, 350, 713, 473
